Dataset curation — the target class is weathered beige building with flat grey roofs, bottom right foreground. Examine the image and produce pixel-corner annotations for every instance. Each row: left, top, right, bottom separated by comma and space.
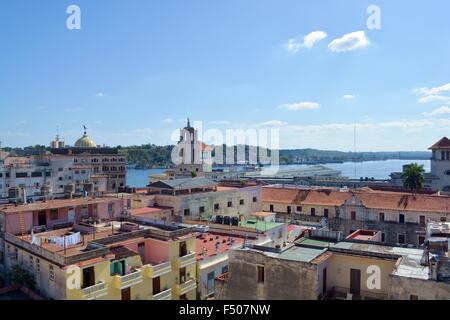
216, 226, 450, 300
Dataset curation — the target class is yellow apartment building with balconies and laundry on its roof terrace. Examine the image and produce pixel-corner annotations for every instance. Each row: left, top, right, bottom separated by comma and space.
3, 221, 196, 300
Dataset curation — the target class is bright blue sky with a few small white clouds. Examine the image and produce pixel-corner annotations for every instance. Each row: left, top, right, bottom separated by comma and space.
0, 0, 450, 151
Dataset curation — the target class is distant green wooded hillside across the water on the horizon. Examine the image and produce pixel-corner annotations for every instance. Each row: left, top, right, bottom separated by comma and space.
4, 144, 431, 168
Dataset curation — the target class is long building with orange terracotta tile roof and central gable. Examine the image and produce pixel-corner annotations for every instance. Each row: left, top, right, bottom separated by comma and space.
262, 185, 450, 247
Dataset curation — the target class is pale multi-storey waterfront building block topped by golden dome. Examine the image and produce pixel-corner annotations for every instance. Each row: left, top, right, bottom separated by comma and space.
0, 127, 126, 202
